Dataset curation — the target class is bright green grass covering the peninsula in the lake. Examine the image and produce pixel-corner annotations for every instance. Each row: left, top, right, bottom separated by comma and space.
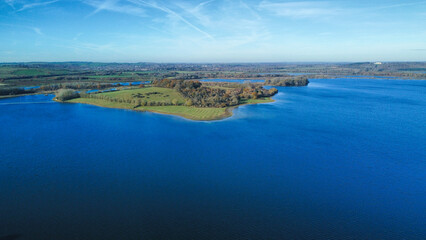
67, 87, 273, 121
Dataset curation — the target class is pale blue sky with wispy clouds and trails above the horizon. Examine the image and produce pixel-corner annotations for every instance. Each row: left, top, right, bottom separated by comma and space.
0, 0, 426, 63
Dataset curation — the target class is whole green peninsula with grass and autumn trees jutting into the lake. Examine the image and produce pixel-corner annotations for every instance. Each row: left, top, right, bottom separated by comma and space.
55, 79, 307, 121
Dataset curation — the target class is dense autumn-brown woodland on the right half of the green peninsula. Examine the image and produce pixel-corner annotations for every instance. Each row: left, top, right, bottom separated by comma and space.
153, 79, 278, 107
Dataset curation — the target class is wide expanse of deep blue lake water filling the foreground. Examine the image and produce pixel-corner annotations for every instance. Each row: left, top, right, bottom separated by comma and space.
0, 80, 426, 240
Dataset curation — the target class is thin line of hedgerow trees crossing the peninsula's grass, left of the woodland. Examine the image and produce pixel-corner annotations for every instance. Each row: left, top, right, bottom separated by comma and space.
80, 93, 183, 108
